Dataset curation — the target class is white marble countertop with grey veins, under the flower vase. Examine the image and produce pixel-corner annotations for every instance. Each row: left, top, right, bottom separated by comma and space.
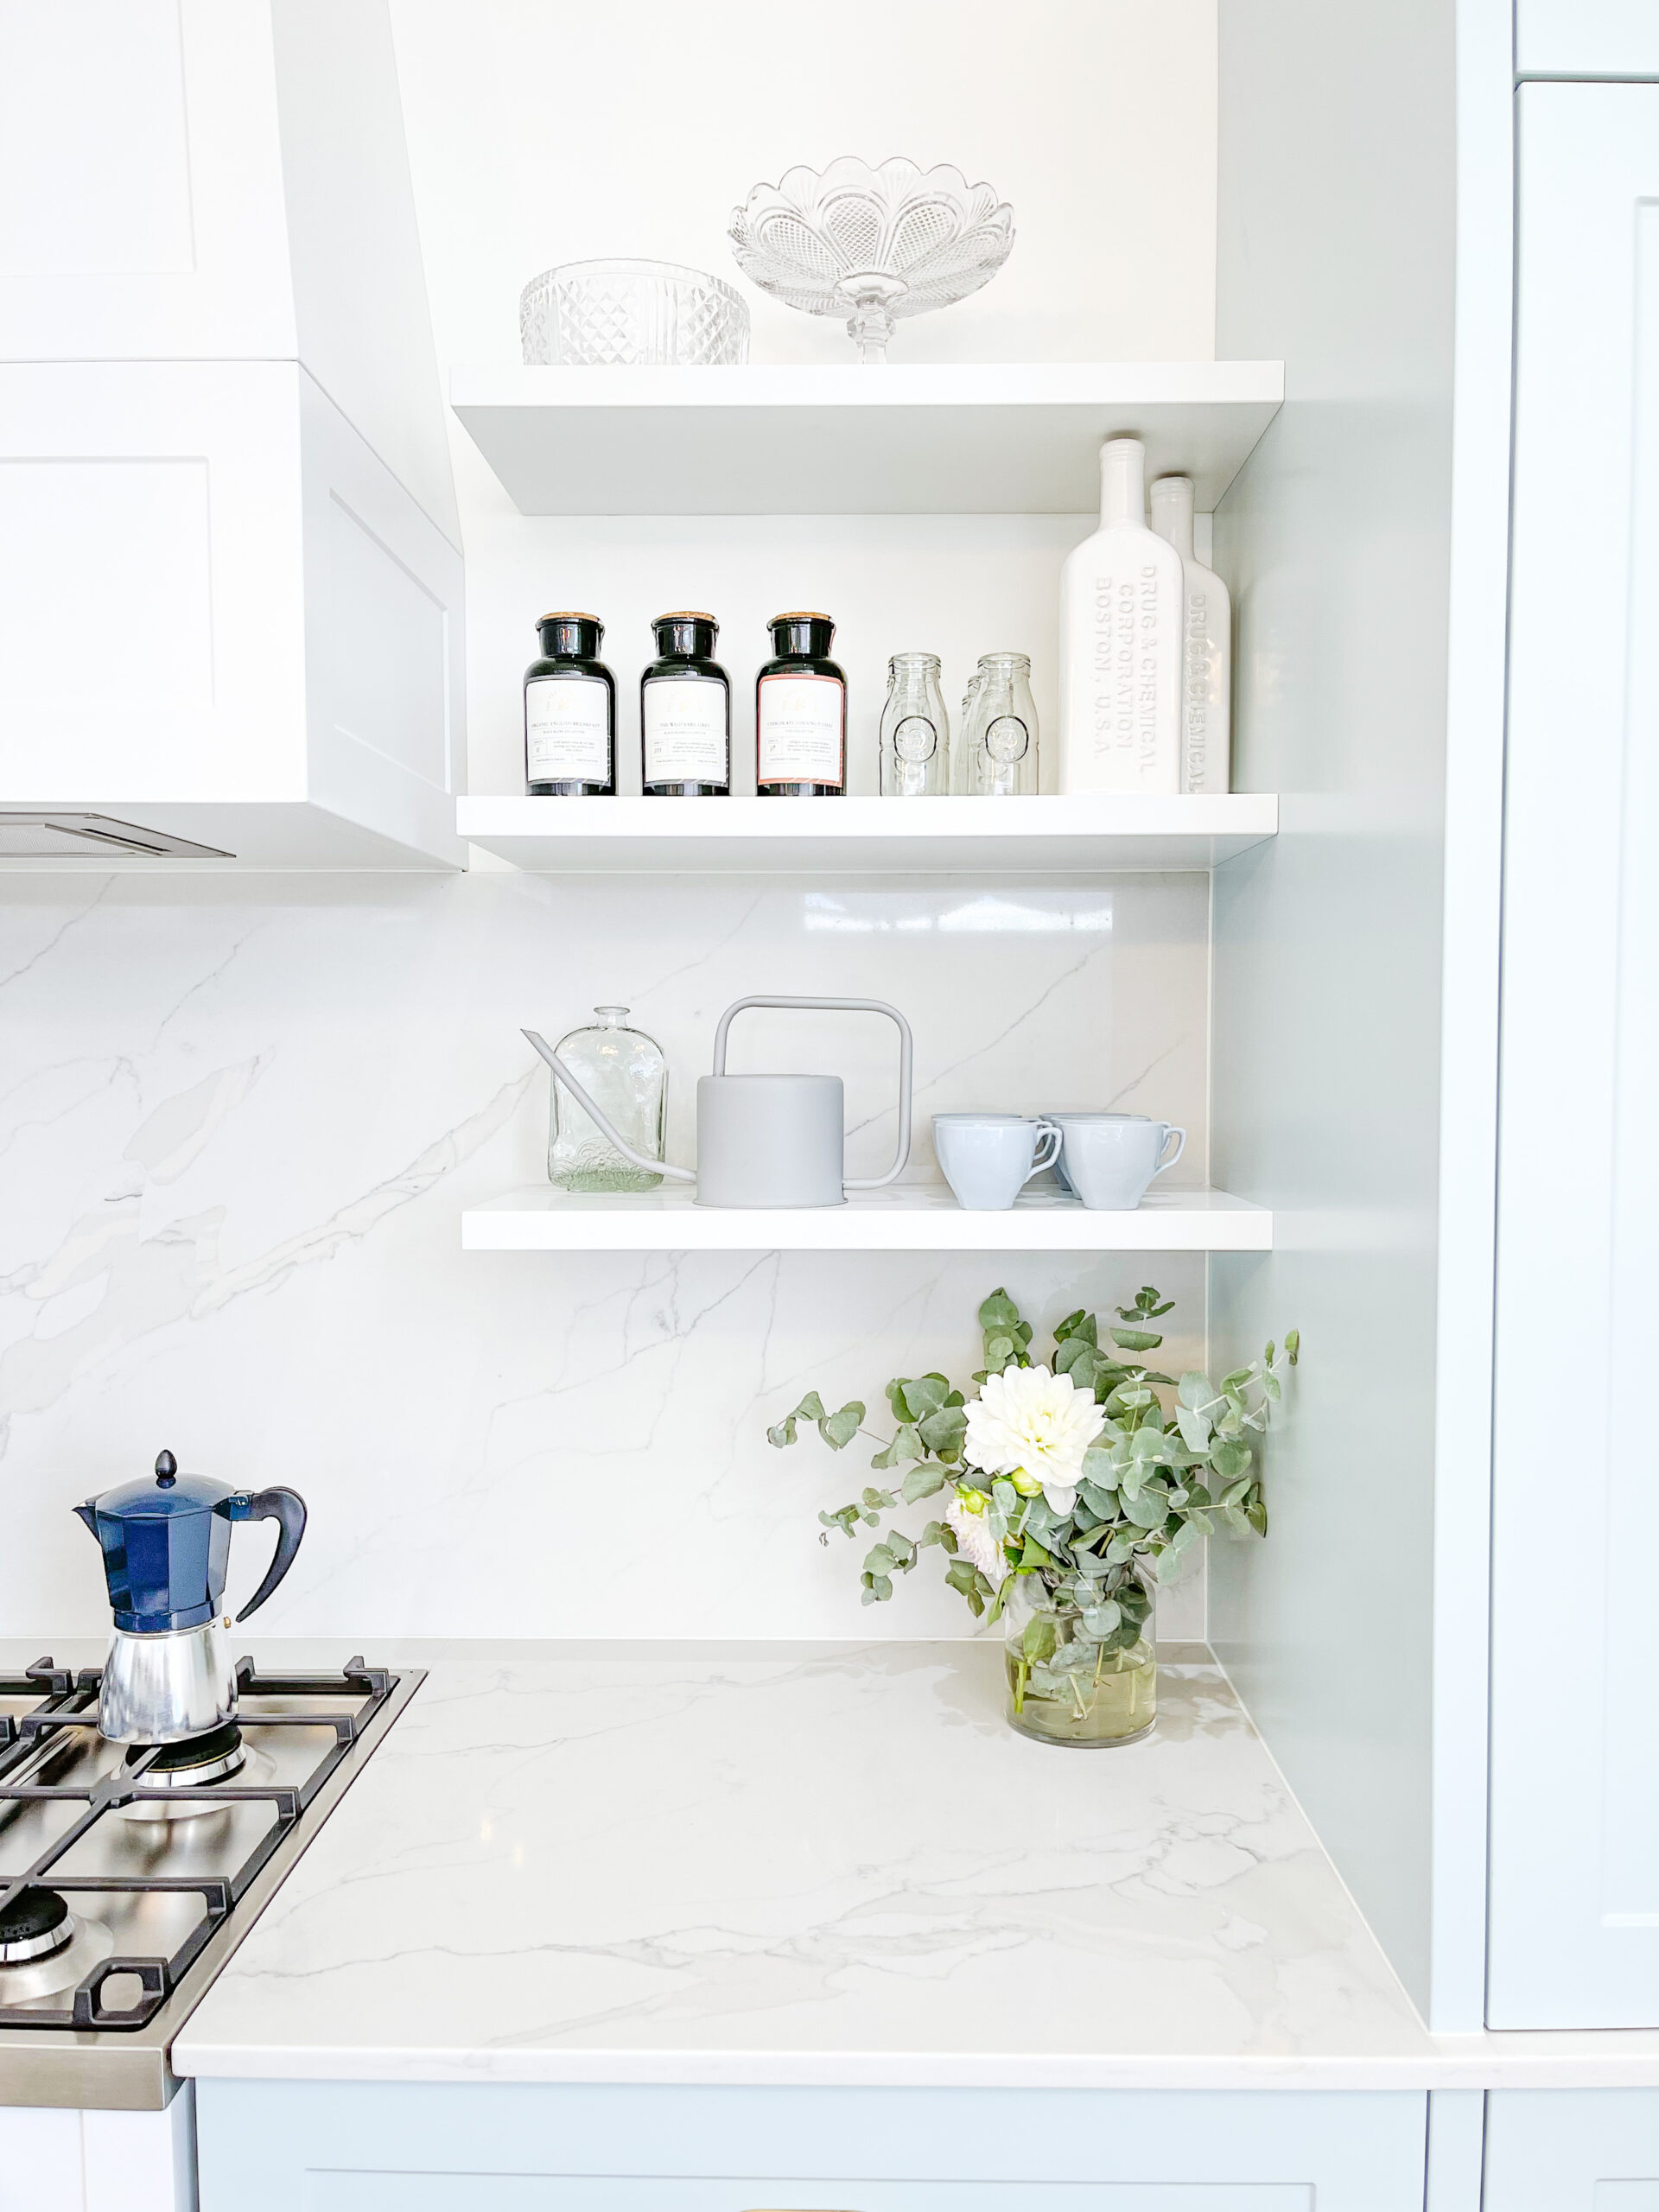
159, 1643, 1659, 2088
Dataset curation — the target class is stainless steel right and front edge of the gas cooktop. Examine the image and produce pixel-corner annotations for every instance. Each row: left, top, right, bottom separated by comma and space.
0, 1668, 427, 2113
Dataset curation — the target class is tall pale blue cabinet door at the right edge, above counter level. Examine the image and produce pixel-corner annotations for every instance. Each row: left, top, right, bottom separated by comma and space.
1489, 84, 1659, 2025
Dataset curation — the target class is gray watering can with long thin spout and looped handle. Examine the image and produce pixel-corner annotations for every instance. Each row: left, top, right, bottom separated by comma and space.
524, 998, 913, 1205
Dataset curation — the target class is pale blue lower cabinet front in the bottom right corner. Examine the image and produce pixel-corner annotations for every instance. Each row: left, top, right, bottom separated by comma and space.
1482, 2088, 1659, 2212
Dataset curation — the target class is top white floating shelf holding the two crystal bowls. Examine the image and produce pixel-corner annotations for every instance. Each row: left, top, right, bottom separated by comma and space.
449, 360, 1285, 515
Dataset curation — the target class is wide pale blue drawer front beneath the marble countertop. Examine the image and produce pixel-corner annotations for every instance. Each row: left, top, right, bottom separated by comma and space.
197, 2082, 1433, 2212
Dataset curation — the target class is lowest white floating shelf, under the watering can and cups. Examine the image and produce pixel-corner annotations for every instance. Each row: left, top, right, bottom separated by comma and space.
460, 1184, 1274, 1252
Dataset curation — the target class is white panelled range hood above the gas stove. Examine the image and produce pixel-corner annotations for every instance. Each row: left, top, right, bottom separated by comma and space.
0, 0, 465, 868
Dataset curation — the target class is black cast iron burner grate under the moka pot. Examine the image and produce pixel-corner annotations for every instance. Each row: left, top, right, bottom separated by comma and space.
0, 1656, 398, 2033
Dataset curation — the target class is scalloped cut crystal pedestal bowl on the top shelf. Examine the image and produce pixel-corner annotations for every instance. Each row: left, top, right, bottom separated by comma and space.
728, 155, 1013, 360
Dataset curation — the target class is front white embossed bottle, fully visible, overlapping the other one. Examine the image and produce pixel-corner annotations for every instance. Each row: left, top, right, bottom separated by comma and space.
1059, 438, 1181, 791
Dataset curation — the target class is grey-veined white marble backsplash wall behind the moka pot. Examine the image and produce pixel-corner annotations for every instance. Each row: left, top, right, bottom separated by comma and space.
0, 872, 1208, 1639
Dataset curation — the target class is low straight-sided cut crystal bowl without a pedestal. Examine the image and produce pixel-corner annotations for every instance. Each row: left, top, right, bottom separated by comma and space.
518, 261, 750, 370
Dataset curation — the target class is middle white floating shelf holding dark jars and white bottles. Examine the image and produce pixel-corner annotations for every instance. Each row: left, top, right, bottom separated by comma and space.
455, 791, 1279, 876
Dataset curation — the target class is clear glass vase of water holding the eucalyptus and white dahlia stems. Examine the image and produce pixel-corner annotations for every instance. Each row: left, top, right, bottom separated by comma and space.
1004, 1577, 1157, 1750
